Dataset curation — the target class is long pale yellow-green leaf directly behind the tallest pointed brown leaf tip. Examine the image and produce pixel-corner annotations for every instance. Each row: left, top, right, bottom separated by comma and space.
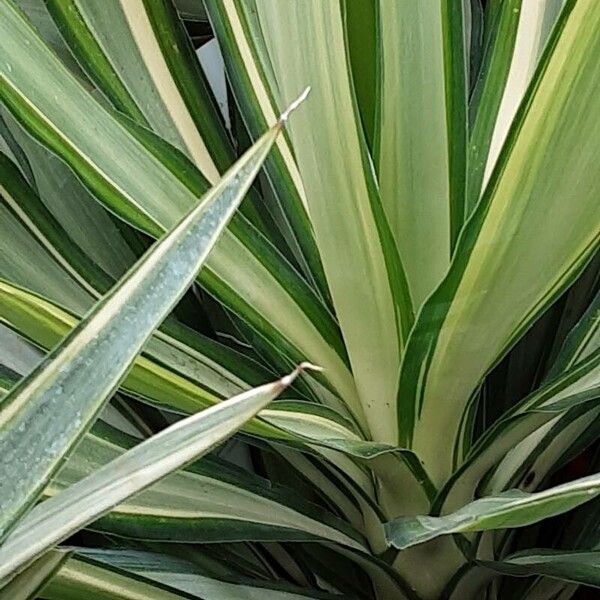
240, 0, 412, 443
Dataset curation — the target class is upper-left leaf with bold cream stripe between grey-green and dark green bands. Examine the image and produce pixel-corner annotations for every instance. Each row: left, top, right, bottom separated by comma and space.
47, 0, 227, 184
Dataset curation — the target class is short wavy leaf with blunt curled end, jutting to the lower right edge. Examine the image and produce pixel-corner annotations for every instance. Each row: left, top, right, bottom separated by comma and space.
385, 474, 600, 550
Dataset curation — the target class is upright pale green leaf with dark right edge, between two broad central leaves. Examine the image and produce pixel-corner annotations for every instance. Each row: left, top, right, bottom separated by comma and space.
375, 0, 467, 307
